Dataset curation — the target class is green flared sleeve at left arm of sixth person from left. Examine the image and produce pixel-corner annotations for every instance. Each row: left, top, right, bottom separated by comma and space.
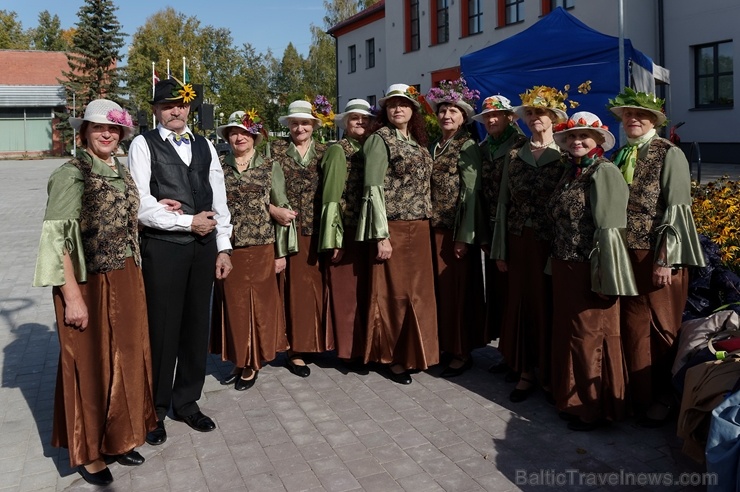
356, 134, 390, 241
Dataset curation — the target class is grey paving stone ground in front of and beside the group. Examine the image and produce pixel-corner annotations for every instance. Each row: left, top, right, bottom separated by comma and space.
0, 159, 740, 492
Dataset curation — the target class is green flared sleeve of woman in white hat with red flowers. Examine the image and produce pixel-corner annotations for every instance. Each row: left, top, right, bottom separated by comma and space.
590, 161, 637, 296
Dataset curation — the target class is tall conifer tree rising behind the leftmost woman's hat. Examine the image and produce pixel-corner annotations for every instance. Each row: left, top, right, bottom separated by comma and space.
57, 0, 124, 152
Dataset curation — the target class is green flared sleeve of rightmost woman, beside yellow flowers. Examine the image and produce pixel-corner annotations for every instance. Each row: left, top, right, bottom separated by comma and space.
655, 147, 705, 267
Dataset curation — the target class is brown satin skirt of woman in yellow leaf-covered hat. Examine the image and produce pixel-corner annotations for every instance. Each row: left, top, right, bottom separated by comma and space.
499, 227, 552, 386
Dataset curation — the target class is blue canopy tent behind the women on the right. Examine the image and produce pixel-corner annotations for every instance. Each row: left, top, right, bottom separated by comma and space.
460, 7, 667, 144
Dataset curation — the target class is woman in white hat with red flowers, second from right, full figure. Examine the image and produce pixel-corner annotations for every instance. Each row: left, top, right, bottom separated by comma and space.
548, 111, 637, 431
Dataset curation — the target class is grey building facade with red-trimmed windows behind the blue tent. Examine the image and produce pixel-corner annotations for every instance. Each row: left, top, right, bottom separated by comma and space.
329, 0, 740, 157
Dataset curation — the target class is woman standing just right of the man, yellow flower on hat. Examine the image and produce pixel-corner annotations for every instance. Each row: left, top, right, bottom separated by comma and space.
211, 109, 288, 391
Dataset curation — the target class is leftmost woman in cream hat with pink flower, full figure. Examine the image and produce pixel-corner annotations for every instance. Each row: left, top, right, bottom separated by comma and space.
33, 99, 157, 485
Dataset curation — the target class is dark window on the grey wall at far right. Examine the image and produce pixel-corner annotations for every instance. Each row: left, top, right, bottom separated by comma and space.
694, 41, 735, 108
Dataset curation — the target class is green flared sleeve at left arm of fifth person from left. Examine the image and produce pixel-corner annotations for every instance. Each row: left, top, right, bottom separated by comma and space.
319, 144, 347, 251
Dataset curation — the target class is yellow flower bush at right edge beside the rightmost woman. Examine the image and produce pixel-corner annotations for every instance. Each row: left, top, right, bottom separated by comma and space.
691, 176, 740, 273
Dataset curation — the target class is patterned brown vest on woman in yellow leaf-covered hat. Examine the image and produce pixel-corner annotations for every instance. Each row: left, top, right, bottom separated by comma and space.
508, 142, 566, 241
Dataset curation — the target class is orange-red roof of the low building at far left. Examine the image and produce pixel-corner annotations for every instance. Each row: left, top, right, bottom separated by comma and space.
0, 50, 69, 85
